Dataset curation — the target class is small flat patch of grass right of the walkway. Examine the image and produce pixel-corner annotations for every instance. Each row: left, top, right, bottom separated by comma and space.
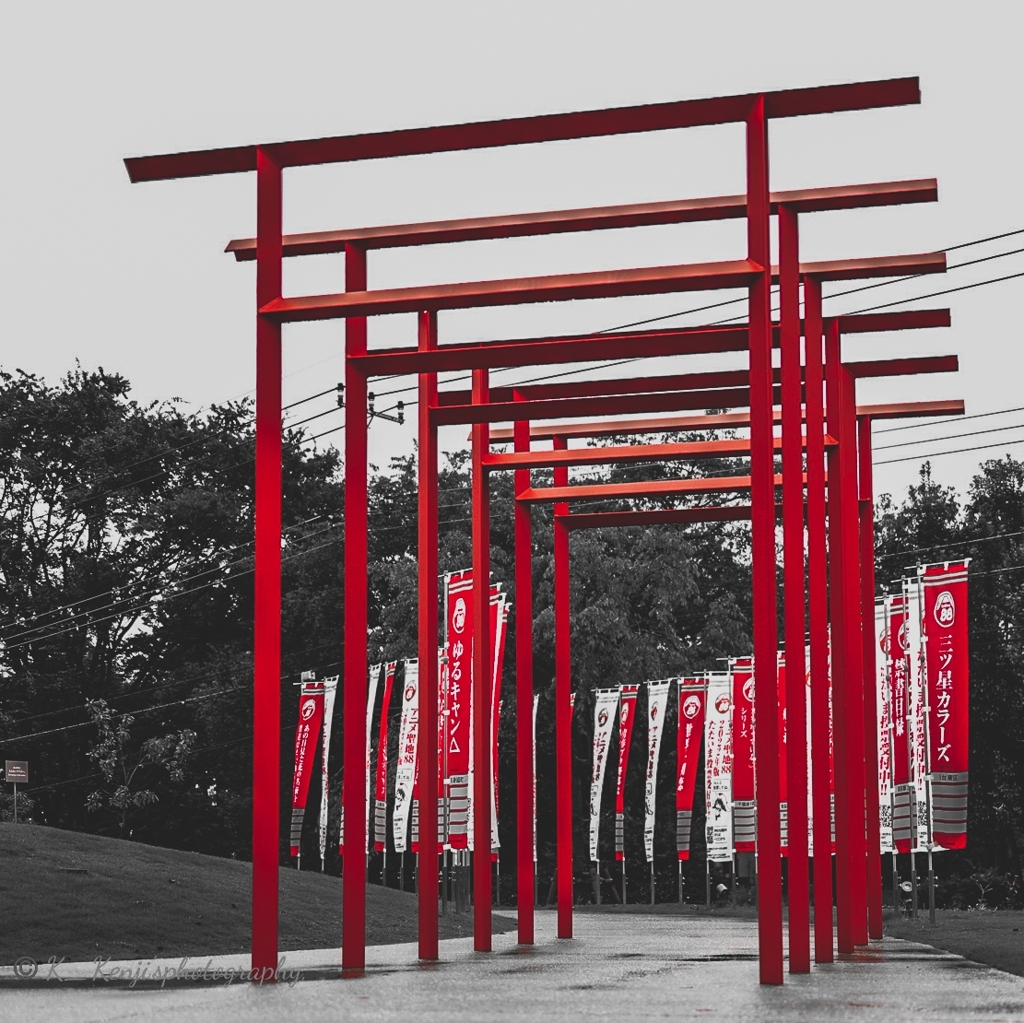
886, 909, 1024, 977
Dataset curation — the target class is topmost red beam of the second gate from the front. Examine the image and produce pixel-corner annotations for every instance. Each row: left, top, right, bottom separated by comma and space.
224, 178, 939, 256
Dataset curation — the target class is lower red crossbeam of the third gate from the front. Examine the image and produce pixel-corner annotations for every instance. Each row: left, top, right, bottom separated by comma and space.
430, 386, 761, 426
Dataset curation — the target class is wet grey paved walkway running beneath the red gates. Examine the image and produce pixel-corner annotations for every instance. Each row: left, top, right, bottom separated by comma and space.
0, 913, 1024, 1023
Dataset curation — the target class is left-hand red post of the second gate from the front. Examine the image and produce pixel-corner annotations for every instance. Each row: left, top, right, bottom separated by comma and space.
341, 245, 372, 971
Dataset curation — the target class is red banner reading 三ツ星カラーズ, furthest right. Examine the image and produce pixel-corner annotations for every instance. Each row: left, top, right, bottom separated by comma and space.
919, 561, 970, 849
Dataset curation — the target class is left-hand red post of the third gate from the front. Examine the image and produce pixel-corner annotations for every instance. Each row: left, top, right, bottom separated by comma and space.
417, 312, 438, 960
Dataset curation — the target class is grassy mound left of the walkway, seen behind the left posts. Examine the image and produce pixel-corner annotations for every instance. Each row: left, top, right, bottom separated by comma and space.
0, 824, 515, 964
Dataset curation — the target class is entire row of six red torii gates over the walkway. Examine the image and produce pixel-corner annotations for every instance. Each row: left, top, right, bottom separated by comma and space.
126, 78, 964, 984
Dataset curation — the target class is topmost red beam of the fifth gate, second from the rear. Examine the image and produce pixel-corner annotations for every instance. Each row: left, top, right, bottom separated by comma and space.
437, 355, 959, 405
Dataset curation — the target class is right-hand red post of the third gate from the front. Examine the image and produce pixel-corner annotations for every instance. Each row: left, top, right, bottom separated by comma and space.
804, 278, 835, 963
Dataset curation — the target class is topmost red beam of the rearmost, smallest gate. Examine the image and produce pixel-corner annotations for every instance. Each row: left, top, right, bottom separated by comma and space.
490, 399, 964, 443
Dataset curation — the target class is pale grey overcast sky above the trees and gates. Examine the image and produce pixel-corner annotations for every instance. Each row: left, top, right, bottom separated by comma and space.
0, 0, 1024, 503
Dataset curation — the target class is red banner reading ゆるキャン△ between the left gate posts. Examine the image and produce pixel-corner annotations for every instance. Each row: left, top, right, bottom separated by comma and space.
444, 569, 473, 849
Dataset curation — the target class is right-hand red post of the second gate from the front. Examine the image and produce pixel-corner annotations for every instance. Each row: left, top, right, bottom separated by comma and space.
778, 205, 811, 973
